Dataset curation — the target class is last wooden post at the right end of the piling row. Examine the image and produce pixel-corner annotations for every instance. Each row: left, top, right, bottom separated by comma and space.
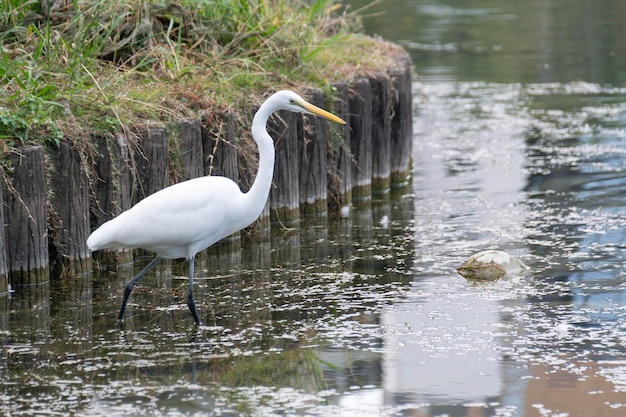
390, 60, 413, 187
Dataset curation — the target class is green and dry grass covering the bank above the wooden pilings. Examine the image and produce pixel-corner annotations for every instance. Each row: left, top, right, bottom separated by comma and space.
0, 0, 400, 153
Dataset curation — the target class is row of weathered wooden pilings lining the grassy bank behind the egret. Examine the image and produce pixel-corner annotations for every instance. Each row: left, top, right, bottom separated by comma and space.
0, 61, 412, 294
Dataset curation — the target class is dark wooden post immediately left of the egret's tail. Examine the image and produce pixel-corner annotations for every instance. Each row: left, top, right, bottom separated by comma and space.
49, 141, 91, 276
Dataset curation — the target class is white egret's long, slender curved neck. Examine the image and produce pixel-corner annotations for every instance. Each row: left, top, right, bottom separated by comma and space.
247, 101, 274, 219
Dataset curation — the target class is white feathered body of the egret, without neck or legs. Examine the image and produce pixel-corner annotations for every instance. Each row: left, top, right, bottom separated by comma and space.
87, 176, 263, 259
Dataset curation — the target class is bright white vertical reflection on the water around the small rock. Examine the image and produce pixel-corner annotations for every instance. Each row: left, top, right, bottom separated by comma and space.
382, 83, 527, 410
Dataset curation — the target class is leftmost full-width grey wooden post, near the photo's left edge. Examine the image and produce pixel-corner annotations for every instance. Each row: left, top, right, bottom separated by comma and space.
5, 146, 50, 288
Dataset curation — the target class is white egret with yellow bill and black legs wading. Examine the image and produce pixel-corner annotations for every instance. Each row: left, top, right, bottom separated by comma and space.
87, 90, 345, 324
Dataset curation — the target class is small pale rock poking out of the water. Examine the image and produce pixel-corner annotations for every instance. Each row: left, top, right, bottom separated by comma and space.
456, 250, 528, 281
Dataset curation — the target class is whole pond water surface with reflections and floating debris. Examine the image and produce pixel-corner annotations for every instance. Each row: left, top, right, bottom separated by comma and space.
0, 0, 626, 417
